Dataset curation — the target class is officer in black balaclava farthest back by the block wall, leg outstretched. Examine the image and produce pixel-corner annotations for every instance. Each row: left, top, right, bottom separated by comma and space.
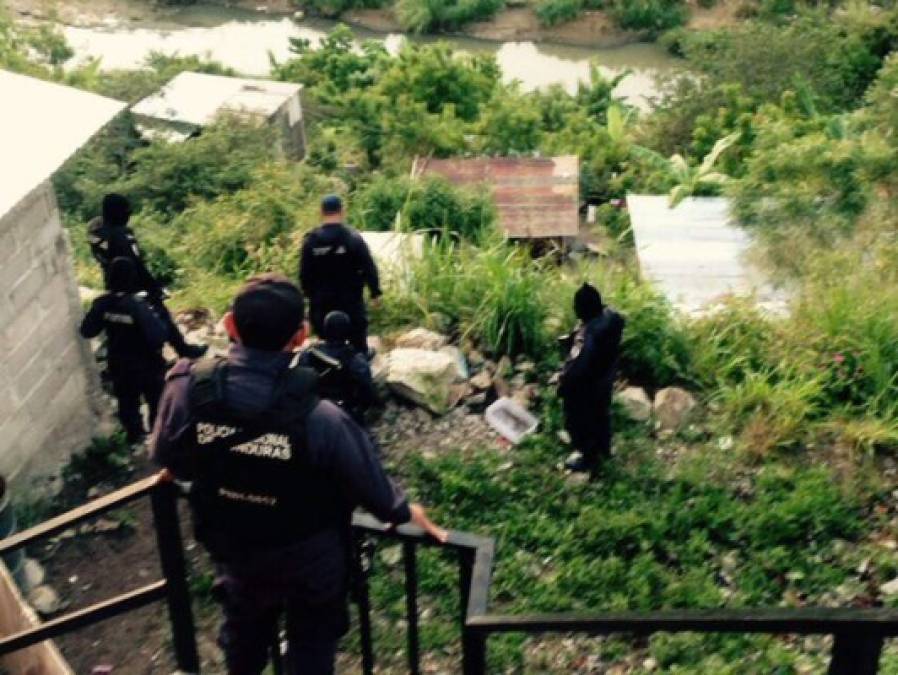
87, 193, 208, 359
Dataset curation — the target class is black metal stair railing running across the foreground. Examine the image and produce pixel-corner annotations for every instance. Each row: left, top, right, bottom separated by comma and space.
0, 477, 898, 675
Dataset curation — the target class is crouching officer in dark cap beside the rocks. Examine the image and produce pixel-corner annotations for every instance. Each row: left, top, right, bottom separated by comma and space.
299, 312, 377, 424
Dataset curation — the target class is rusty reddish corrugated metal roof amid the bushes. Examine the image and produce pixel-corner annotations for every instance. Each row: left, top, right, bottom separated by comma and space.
412, 155, 580, 239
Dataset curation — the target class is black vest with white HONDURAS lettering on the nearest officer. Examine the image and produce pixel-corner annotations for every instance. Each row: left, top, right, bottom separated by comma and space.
189, 359, 346, 560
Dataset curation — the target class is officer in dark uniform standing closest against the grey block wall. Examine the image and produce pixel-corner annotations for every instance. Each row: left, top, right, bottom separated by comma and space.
81, 258, 168, 443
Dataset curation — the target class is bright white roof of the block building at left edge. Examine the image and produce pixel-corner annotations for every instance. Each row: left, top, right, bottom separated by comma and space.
0, 70, 125, 216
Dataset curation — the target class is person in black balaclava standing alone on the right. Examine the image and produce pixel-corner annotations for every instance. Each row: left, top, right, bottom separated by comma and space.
558, 283, 624, 476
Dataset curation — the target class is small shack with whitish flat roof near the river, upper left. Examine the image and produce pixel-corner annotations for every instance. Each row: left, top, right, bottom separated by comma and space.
131, 72, 306, 159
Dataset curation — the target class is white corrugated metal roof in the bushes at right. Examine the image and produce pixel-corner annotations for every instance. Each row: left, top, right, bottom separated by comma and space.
627, 195, 787, 314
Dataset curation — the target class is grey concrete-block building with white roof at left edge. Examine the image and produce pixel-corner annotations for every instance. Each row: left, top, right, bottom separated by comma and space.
0, 71, 124, 482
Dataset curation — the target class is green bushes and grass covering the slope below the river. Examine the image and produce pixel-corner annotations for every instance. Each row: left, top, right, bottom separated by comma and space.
8, 2, 898, 673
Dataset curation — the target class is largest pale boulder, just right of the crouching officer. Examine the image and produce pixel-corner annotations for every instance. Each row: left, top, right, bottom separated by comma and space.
387, 348, 459, 415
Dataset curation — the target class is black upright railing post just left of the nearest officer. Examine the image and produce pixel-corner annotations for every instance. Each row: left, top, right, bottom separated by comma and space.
151, 482, 200, 673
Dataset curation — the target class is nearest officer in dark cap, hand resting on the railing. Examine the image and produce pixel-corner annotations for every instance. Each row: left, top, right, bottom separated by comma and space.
153, 275, 447, 675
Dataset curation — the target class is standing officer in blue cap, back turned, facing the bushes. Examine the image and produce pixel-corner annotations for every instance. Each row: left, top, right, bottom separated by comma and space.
299, 195, 381, 354
